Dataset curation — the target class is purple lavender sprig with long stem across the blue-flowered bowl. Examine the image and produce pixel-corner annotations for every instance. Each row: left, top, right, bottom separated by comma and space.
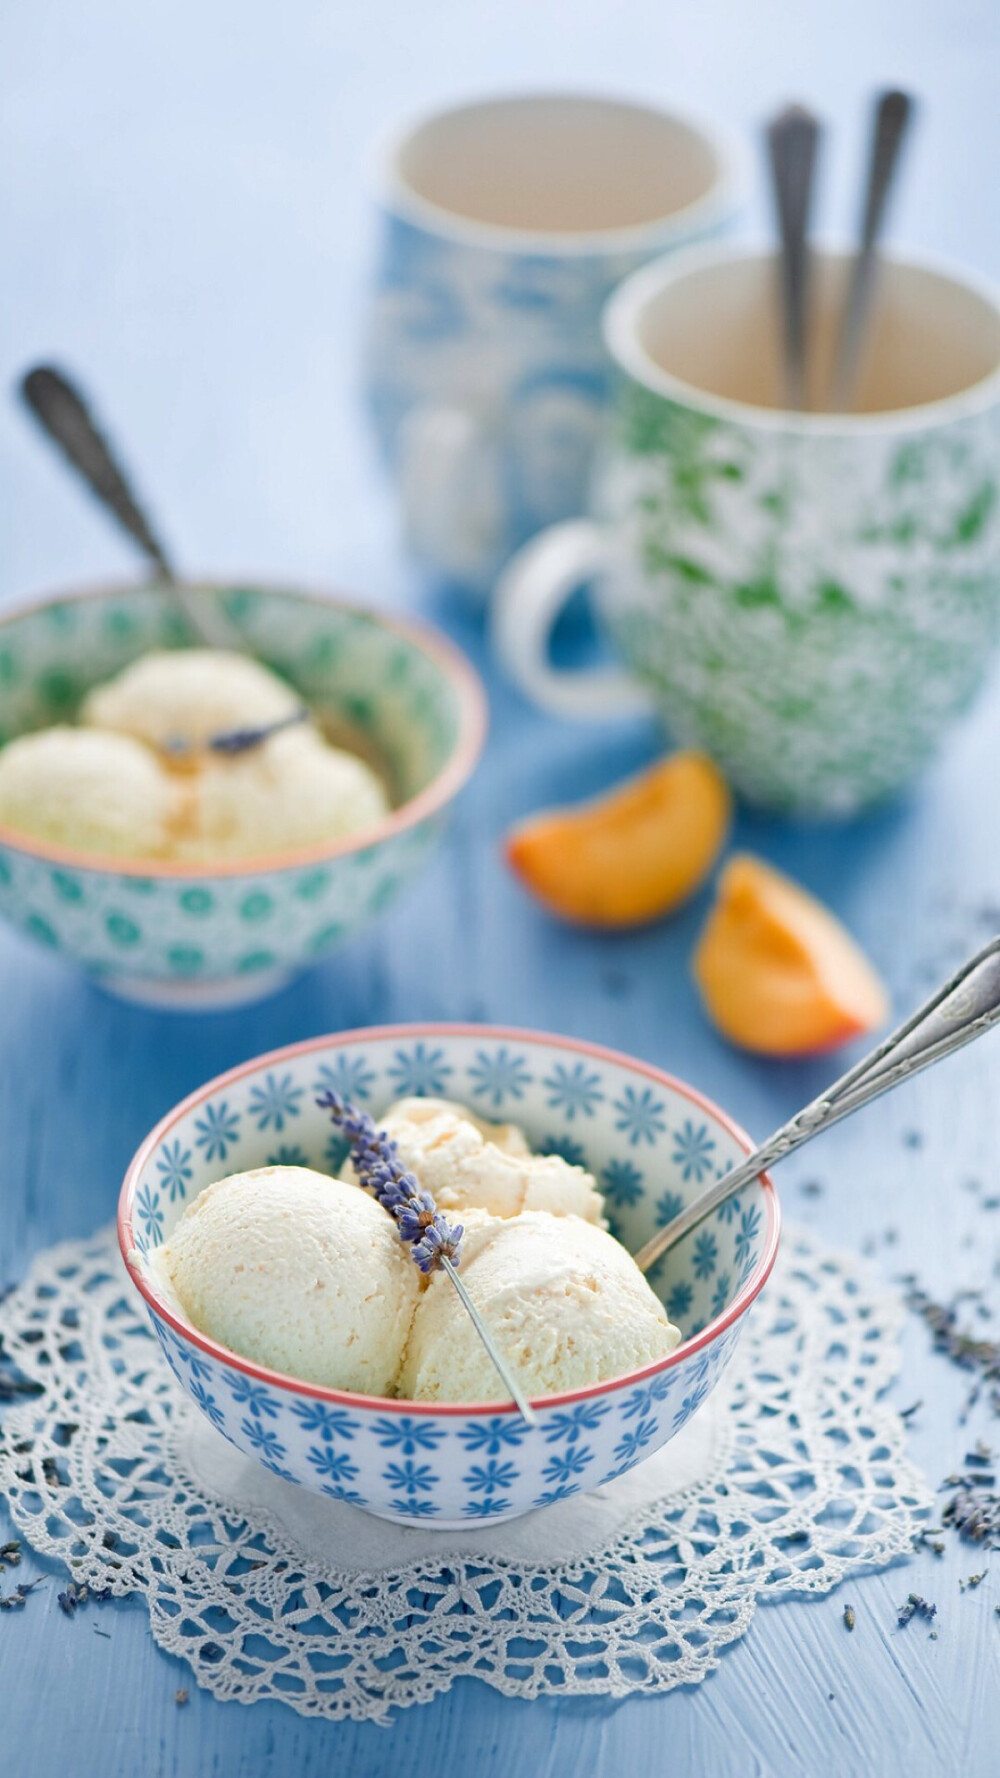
317, 1090, 537, 1426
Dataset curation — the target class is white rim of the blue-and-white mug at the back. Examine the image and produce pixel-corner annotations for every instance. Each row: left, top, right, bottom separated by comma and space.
374, 87, 747, 260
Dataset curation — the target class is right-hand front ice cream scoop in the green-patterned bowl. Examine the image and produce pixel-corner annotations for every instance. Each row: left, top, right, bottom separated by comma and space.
178, 727, 388, 862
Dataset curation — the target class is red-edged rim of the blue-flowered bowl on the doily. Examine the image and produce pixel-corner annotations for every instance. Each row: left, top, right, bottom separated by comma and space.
117, 1022, 781, 1417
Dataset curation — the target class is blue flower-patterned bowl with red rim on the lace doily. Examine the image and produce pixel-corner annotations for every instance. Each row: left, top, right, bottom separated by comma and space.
117, 1024, 779, 1527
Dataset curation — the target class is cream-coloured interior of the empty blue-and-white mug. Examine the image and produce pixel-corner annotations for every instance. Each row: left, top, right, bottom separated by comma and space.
391, 94, 724, 249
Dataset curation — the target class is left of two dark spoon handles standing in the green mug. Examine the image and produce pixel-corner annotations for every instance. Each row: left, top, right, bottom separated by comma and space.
767, 105, 820, 409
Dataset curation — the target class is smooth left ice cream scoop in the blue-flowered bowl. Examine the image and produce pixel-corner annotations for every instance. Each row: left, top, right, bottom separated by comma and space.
153, 1166, 420, 1396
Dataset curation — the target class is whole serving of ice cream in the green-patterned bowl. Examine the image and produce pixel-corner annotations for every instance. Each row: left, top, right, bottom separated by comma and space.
0, 649, 390, 866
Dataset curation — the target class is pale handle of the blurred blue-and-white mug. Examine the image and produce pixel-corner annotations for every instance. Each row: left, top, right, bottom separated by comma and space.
399, 404, 507, 589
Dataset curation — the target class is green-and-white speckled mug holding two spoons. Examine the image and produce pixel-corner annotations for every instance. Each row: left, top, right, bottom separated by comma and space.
495, 249, 1000, 816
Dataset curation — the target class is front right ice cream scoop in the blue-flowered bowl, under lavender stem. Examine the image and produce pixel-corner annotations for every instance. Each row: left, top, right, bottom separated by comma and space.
397, 1211, 680, 1401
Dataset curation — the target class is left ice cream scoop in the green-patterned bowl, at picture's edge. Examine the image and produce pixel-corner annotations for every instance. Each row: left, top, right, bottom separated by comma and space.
0, 727, 178, 859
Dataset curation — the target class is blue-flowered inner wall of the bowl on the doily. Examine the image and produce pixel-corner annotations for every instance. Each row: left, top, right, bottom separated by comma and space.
123, 1028, 778, 1339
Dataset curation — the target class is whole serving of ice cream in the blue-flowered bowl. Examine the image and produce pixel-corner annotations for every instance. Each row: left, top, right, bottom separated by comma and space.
149, 1099, 680, 1401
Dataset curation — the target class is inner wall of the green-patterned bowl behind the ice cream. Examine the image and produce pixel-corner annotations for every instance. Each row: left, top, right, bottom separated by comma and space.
0, 583, 463, 804
